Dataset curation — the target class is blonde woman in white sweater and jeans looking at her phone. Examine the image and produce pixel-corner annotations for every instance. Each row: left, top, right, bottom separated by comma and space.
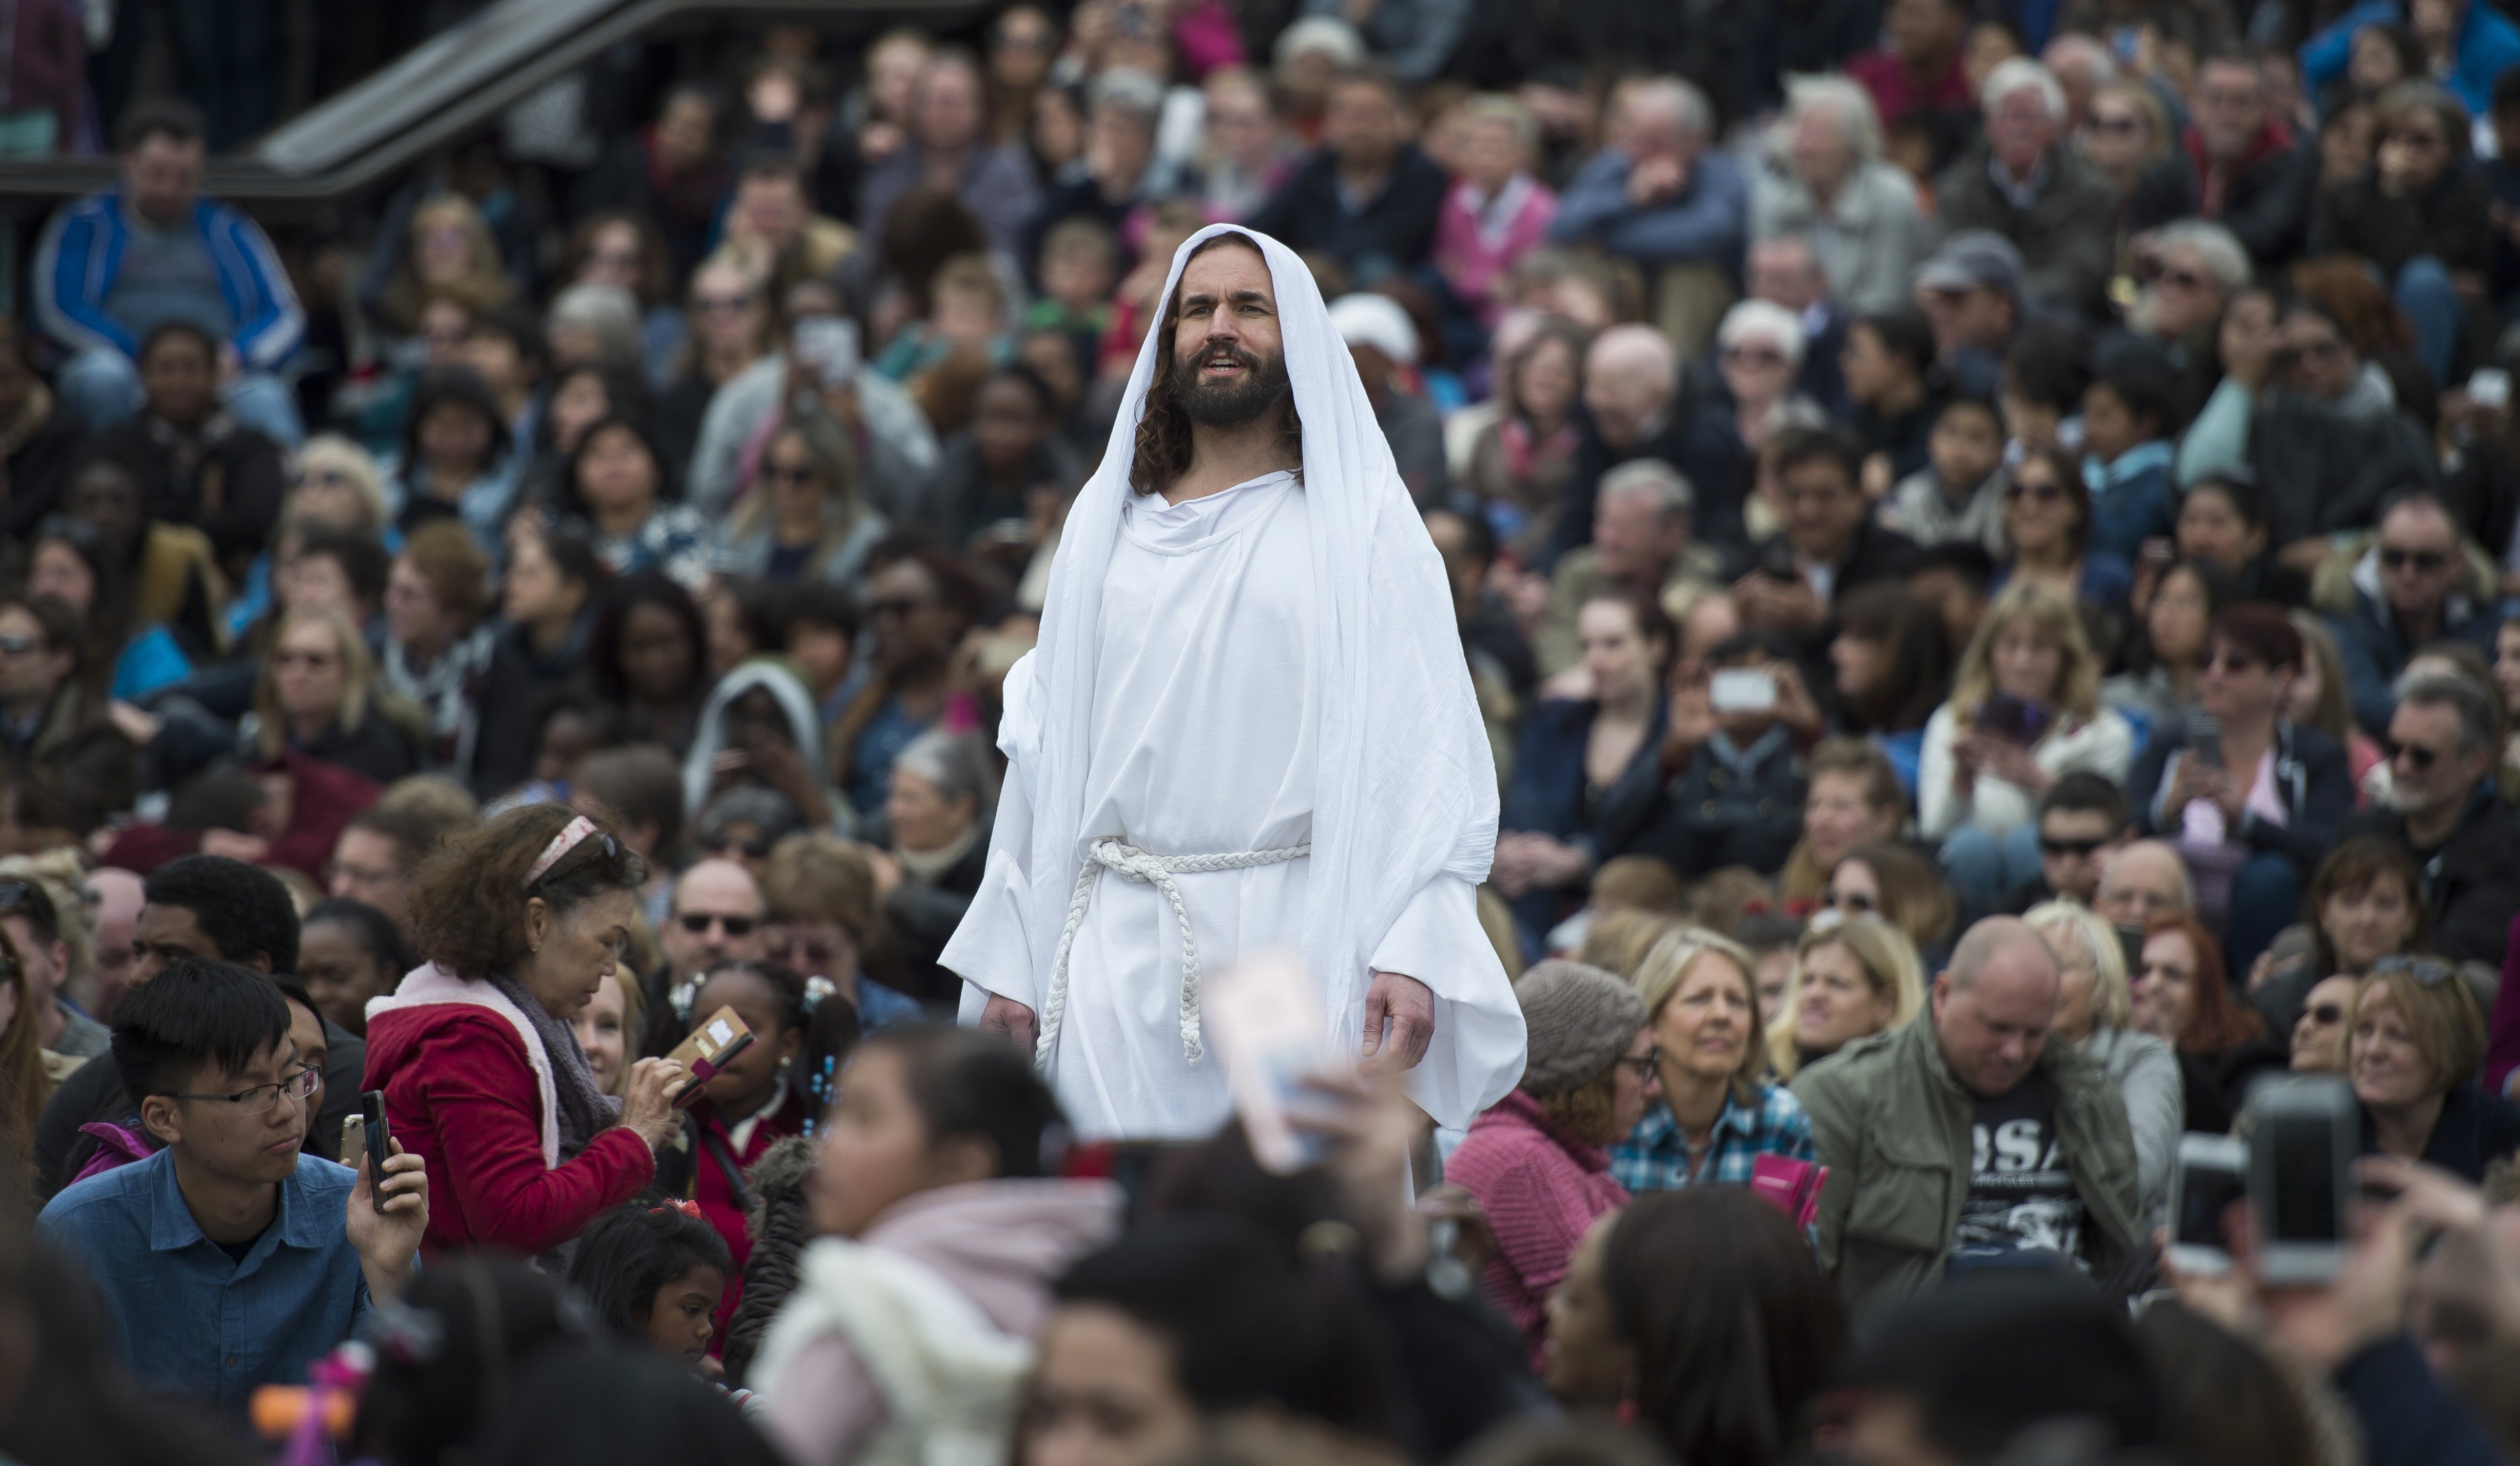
1915, 580, 2135, 917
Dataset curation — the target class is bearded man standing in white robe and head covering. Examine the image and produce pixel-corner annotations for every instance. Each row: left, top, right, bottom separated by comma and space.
942, 227, 1522, 1139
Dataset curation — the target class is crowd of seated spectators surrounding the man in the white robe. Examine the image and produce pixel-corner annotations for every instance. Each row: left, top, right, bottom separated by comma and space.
0, 0, 2520, 1466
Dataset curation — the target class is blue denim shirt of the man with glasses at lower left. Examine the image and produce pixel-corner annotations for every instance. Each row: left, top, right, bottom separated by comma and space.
35, 1149, 373, 1418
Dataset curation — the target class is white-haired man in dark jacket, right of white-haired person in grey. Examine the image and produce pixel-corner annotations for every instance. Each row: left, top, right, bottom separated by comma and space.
1933, 55, 2117, 320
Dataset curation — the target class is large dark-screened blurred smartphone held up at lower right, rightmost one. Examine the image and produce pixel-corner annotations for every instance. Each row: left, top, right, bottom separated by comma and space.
2243, 1075, 2361, 1285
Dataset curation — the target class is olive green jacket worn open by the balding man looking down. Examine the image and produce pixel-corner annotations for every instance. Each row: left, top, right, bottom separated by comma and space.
1794, 1008, 2140, 1313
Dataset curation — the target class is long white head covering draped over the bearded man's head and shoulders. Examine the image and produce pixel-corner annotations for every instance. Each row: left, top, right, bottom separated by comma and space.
1000, 224, 1522, 1124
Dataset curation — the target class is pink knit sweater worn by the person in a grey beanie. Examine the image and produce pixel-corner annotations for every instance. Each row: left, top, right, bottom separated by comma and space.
1444, 1088, 1628, 1373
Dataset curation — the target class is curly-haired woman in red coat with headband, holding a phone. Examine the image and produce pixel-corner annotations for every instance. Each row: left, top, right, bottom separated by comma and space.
368, 803, 688, 1257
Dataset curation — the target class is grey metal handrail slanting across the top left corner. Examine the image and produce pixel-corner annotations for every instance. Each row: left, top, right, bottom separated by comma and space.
0, 0, 983, 204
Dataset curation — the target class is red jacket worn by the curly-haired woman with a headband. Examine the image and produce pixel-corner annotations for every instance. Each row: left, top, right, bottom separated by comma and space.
368, 1005, 655, 1257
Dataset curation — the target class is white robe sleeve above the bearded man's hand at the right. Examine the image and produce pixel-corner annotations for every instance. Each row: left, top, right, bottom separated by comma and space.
1371, 872, 1525, 1128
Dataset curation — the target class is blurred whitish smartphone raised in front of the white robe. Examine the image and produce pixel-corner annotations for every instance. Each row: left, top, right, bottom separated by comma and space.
1199, 952, 1343, 1176
